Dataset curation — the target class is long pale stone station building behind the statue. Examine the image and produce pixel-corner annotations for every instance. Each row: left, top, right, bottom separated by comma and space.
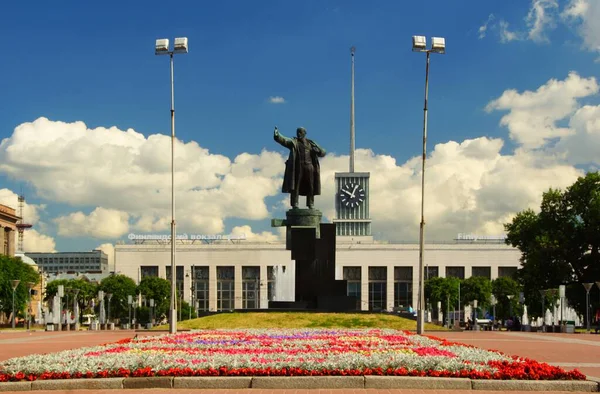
115, 242, 521, 311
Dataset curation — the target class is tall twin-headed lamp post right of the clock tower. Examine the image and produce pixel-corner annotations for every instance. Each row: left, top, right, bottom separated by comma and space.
412, 36, 446, 334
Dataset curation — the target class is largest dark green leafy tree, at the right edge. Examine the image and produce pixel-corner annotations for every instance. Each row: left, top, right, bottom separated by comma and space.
505, 172, 600, 314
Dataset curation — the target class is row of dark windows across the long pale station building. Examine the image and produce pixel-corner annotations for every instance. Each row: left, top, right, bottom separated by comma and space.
140, 266, 517, 311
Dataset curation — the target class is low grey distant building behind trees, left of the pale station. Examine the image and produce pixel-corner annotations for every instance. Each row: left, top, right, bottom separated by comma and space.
25, 250, 108, 274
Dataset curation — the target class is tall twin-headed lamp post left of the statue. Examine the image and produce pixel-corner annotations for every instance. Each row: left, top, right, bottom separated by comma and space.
154, 37, 188, 334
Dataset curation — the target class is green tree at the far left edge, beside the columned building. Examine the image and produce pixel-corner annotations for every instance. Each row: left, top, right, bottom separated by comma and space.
0, 255, 40, 322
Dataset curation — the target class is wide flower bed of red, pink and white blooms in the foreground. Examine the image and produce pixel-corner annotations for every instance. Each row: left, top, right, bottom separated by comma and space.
0, 329, 585, 382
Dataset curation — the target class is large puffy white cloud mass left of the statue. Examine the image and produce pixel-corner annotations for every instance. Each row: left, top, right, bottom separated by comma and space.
0, 118, 284, 238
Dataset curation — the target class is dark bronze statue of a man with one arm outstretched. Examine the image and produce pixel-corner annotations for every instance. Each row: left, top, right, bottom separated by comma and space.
273, 127, 325, 209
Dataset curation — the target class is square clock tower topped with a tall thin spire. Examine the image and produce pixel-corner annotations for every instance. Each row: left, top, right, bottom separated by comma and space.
333, 47, 373, 243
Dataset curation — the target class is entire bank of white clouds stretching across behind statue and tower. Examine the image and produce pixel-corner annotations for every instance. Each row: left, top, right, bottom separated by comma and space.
0, 72, 600, 242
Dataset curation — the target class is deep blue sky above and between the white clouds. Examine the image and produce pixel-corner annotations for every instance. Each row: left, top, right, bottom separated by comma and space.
0, 0, 600, 254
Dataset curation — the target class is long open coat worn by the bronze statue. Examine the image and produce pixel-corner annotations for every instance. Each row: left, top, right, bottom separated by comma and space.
274, 134, 325, 196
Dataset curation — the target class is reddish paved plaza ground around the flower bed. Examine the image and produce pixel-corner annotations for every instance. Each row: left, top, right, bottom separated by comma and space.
0, 330, 600, 394
